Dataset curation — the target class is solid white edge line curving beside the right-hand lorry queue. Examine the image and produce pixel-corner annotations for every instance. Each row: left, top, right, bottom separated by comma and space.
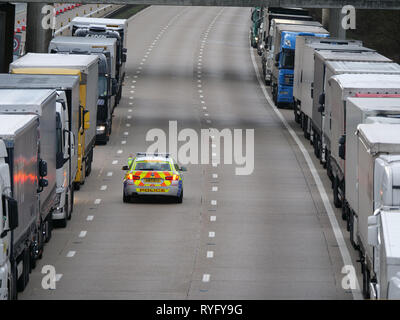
250, 39, 363, 300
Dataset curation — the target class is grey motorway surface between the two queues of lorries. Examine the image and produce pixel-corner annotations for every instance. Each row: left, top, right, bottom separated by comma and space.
19, 6, 359, 299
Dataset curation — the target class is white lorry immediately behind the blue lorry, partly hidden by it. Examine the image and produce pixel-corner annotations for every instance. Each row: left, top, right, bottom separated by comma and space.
261, 19, 322, 85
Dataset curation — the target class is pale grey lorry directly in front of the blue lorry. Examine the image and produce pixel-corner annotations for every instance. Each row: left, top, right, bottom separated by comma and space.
293, 36, 362, 141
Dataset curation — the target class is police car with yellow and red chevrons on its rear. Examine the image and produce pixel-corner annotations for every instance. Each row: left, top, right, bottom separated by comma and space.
122, 152, 186, 203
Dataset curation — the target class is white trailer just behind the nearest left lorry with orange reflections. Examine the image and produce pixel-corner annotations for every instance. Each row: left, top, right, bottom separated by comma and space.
0, 89, 57, 260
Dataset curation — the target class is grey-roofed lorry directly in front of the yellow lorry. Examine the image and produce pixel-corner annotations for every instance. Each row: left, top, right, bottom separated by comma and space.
0, 74, 81, 227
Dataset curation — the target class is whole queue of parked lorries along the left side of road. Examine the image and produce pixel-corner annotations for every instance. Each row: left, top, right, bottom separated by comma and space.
0, 17, 128, 300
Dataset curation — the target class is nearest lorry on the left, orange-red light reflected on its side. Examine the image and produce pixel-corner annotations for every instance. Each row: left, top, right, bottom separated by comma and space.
0, 114, 40, 300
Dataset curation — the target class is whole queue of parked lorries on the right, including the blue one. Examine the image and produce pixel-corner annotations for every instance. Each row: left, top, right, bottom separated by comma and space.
250, 7, 400, 299
